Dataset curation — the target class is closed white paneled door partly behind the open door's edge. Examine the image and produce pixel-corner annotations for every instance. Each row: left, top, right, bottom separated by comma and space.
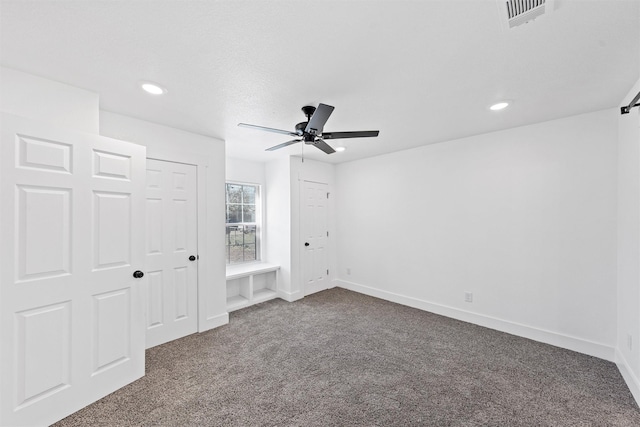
145, 159, 198, 348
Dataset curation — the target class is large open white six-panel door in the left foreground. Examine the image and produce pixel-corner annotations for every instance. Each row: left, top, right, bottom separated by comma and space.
0, 114, 146, 426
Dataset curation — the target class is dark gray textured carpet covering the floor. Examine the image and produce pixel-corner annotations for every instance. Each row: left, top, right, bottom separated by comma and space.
55, 289, 640, 427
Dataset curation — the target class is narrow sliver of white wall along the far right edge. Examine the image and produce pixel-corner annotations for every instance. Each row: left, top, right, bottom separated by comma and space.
617, 80, 640, 402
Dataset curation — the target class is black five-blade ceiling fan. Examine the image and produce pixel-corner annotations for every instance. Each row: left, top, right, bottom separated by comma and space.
238, 104, 380, 154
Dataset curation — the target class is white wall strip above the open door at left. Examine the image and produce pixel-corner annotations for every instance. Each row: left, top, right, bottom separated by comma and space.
0, 67, 99, 134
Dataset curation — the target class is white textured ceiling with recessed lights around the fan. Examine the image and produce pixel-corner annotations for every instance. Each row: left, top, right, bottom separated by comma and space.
0, 0, 640, 163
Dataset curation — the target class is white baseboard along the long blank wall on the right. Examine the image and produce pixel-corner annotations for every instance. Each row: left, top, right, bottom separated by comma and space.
335, 280, 615, 362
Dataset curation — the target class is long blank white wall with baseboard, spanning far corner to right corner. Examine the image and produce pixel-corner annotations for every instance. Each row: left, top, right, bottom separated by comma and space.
336, 110, 617, 360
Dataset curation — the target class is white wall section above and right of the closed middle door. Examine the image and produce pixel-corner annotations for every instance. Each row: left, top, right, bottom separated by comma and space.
100, 111, 229, 332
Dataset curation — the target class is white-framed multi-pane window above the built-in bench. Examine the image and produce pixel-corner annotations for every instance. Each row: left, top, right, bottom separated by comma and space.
226, 183, 260, 264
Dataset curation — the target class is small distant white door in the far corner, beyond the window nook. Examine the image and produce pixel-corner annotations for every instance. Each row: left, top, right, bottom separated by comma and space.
302, 181, 329, 295
